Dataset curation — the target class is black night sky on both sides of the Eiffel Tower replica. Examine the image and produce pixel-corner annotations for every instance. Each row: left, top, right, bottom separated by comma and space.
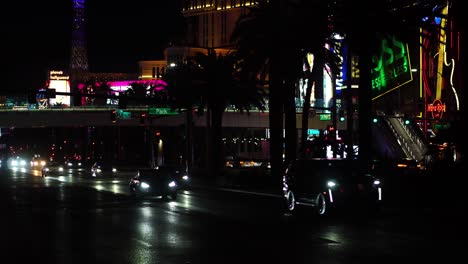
0, 0, 185, 94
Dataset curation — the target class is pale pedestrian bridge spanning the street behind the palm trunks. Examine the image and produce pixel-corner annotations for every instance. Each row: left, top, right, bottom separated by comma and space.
0, 106, 338, 129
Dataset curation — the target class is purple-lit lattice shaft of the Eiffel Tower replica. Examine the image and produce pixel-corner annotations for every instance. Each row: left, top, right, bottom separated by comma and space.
70, 0, 88, 74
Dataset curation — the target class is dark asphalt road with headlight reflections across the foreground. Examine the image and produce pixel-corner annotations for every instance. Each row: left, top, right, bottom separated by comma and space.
0, 167, 467, 264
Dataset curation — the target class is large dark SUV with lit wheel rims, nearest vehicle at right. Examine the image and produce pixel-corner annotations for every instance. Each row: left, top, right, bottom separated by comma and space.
283, 159, 382, 215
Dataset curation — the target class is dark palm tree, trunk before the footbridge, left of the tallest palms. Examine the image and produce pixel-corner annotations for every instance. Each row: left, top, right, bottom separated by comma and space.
195, 48, 265, 176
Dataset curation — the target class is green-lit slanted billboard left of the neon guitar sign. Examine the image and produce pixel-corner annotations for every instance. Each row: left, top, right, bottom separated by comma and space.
371, 36, 413, 100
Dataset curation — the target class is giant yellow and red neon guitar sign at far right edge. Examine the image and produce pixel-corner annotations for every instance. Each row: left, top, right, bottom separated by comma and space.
419, 4, 462, 123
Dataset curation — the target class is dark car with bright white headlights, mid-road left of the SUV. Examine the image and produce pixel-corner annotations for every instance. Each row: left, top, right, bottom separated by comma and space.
129, 167, 179, 200
